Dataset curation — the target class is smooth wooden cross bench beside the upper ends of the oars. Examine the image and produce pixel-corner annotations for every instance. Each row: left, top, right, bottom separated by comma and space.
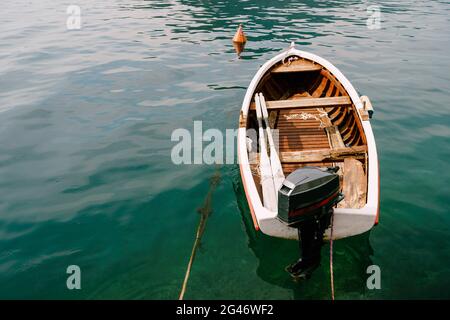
250, 96, 352, 110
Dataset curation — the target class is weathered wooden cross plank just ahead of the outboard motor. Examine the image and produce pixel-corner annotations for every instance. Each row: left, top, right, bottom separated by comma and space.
280, 146, 367, 163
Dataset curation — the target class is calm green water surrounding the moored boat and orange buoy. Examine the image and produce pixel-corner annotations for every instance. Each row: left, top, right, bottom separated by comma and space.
0, 0, 450, 299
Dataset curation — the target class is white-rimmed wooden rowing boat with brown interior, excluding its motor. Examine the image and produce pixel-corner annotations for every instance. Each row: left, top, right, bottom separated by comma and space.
238, 45, 379, 245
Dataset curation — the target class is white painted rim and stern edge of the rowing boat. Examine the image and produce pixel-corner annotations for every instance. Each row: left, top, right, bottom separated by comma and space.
238, 48, 379, 239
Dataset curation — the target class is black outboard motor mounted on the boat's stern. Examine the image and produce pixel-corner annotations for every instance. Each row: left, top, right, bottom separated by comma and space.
278, 167, 344, 278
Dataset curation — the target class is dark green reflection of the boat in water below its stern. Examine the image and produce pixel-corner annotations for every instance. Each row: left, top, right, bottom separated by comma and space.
233, 177, 374, 299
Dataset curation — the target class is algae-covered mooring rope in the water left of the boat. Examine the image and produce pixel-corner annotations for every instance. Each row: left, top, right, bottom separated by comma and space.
178, 169, 220, 300
